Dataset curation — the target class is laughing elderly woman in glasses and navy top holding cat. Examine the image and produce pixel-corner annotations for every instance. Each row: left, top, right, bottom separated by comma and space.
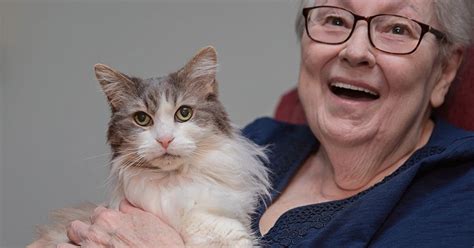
61, 0, 474, 247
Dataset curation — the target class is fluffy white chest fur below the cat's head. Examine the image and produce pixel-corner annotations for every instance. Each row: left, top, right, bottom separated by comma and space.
111, 134, 267, 246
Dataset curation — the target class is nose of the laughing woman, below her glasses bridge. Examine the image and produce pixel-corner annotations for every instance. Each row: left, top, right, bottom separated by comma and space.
339, 22, 375, 67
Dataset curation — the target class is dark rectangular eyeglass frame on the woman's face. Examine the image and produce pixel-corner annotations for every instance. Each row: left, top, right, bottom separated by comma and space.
303, 5, 446, 55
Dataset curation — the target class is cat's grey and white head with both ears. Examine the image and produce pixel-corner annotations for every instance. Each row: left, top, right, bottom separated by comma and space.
96, 48, 231, 171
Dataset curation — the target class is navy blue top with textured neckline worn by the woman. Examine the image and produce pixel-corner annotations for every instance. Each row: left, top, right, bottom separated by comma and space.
243, 118, 474, 248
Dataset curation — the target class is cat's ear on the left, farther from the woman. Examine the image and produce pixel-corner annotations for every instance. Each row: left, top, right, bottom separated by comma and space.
94, 64, 137, 111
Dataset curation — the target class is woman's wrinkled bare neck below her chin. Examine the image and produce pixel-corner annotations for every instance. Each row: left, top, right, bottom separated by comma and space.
310, 120, 434, 200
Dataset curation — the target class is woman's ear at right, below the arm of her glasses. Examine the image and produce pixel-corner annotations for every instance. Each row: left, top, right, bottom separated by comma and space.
430, 47, 464, 108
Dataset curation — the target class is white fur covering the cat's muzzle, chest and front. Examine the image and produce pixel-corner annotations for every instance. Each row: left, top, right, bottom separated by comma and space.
110, 97, 269, 247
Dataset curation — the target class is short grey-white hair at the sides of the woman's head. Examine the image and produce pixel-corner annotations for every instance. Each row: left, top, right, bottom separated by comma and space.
295, 0, 474, 48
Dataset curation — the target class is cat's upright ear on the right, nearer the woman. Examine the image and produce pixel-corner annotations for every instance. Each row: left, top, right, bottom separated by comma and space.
178, 46, 217, 95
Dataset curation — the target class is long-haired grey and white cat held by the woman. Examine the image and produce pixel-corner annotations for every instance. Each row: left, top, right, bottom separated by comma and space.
31, 47, 270, 247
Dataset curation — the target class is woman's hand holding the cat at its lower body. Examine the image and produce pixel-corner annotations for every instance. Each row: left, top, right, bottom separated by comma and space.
58, 200, 184, 248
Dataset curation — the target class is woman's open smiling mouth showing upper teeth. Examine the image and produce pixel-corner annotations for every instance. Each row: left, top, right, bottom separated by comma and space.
329, 82, 380, 101
